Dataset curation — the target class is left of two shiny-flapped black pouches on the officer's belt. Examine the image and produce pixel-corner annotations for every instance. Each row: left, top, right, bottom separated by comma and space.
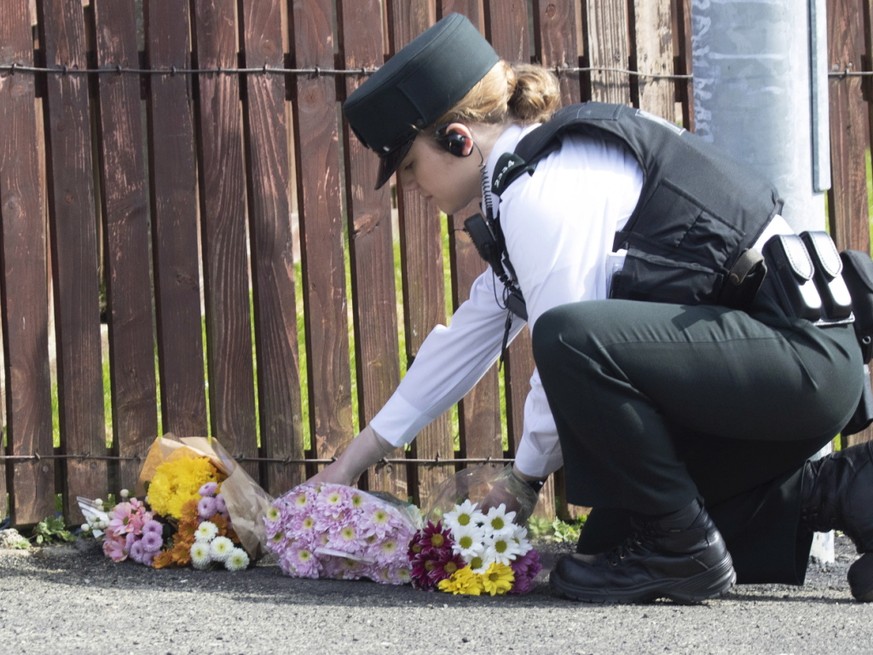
764, 234, 822, 321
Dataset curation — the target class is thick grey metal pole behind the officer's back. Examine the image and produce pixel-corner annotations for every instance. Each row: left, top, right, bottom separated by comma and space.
691, 0, 830, 231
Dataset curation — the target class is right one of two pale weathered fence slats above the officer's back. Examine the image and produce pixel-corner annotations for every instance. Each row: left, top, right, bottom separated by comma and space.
631, 0, 676, 121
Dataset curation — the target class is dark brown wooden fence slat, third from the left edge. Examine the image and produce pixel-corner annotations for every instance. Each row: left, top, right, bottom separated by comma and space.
93, 0, 157, 489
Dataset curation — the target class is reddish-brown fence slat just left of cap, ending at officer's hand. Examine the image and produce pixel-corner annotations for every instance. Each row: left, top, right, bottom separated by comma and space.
291, 0, 354, 472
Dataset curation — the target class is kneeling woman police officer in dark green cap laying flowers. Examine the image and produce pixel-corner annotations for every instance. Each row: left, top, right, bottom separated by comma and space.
315, 14, 873, 603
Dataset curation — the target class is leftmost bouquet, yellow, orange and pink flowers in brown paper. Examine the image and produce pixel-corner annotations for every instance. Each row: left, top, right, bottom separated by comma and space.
78, 436, 269, 571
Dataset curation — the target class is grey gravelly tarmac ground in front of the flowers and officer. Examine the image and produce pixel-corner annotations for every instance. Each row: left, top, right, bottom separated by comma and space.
0, 536, 873, 655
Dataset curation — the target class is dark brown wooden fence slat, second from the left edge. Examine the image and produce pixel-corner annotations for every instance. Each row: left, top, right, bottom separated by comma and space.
38, 0, 108, 522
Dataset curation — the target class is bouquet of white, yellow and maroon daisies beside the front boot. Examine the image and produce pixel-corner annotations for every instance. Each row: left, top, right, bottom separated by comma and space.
409, 500, 542, 596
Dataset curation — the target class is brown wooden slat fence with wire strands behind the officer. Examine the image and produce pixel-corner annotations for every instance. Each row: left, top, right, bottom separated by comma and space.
0, 0, 873, 525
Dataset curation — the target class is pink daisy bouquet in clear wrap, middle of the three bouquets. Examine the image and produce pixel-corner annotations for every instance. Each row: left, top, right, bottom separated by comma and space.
264, 483, 421, 584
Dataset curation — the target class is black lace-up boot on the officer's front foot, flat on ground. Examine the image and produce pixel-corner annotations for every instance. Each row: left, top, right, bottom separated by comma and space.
550, 501, 737, 603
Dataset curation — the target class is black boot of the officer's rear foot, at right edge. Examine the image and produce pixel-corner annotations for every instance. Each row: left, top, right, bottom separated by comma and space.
801, 441, 873, 602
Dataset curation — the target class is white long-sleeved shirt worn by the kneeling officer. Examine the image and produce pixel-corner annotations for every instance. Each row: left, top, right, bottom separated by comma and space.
370, 126, 643, 477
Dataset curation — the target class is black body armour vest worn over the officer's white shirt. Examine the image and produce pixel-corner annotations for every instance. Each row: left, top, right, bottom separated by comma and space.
492, 102, 783, 307
